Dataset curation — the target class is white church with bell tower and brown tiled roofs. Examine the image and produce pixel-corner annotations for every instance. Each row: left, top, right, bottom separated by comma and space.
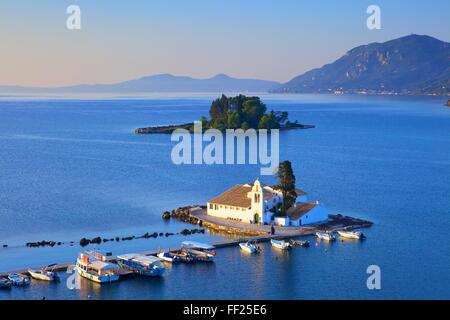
207, 179, 328, 227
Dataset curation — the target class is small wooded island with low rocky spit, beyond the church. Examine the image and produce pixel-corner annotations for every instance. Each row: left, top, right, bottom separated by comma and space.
135, 95, 314, 134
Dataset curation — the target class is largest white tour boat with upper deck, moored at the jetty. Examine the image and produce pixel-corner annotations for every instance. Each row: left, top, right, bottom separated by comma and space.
75, 251, 120, 283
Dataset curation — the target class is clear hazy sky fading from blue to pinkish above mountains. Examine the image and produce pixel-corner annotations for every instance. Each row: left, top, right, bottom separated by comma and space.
0, 0, 450, 86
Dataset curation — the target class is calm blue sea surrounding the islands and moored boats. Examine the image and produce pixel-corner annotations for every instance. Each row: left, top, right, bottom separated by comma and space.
0, 95, 450, 299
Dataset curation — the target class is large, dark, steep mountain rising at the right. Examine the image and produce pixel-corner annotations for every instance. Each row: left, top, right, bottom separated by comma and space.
271, 35, 450, 95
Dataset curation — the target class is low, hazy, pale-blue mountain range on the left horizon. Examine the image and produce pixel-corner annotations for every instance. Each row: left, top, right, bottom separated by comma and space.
0, 74, 279, 94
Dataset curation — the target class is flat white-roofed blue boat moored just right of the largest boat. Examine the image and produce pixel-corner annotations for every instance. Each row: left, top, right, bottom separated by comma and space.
116, 253, 165, 277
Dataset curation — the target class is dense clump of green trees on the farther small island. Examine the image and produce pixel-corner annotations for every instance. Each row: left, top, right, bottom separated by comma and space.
201, 94, 290, 131
